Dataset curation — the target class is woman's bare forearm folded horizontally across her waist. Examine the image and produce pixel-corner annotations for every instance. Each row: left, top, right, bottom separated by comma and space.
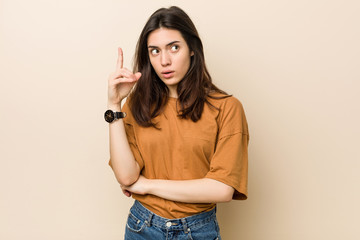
122, 176, 234, 203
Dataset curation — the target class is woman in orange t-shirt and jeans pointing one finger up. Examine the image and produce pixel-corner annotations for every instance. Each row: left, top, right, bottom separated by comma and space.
105, 7, 249, 239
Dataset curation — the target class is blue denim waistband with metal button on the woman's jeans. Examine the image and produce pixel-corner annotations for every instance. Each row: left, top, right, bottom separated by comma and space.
130, 200, 216, 233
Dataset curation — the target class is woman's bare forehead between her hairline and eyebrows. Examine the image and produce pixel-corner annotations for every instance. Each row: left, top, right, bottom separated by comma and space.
147, 28, 185, 47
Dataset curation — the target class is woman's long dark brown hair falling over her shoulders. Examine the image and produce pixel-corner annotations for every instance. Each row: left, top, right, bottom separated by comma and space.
129, 6, 228, 127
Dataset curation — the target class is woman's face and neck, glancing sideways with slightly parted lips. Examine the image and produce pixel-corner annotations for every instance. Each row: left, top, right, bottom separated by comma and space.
147, 28, 194, 97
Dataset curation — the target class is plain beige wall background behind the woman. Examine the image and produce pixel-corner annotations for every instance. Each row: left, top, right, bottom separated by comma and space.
0, 0, 360, 240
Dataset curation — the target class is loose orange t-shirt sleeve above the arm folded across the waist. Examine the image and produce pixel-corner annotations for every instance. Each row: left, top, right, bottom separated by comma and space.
205, 97, 249, 200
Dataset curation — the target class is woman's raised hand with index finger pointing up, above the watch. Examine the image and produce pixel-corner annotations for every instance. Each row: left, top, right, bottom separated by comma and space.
108, 48, 141, 110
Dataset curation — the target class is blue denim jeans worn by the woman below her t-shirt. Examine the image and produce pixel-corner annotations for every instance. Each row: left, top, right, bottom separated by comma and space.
125, 200, 221, 240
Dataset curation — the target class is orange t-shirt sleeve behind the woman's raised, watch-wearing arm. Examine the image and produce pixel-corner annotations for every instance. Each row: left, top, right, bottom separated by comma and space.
109, 102, 144, 171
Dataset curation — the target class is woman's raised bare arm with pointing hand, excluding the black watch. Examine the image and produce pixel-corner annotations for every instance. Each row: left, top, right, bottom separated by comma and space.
108, 48, 141, 186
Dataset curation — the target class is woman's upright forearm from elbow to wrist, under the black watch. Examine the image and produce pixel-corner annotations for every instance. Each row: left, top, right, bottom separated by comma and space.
109, 105, 140, 186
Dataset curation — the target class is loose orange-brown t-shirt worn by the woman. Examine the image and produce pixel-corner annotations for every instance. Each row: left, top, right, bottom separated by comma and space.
109, 94, 249, 219
